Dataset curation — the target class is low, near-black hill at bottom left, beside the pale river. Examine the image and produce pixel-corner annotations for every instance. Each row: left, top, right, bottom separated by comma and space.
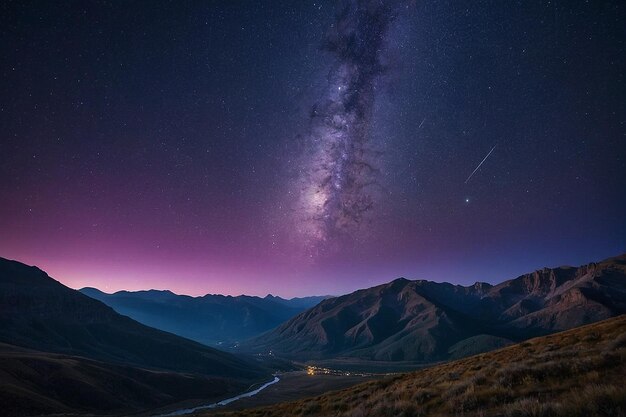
0, 344, 248, 416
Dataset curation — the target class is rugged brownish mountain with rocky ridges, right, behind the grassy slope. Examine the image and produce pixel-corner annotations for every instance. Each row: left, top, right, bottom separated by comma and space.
242, 255, 626, 361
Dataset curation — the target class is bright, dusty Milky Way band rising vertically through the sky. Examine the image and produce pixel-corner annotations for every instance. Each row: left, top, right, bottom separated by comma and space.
295, 1, 396, 251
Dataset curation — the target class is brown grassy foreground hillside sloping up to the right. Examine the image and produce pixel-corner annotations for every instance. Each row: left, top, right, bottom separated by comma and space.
207, 316, 626, 417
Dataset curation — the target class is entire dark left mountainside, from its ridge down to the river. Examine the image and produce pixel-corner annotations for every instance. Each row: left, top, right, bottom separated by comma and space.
0, 258, 269, 412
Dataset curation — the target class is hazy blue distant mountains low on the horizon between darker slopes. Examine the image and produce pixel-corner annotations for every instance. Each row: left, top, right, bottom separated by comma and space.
80, 288, 327, 345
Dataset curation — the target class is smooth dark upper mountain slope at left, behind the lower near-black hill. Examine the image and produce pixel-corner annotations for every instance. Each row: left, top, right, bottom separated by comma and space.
0, 258, 266, 379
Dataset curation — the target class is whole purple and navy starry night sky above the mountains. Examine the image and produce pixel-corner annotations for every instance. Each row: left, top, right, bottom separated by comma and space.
0, 0, 626, 297
